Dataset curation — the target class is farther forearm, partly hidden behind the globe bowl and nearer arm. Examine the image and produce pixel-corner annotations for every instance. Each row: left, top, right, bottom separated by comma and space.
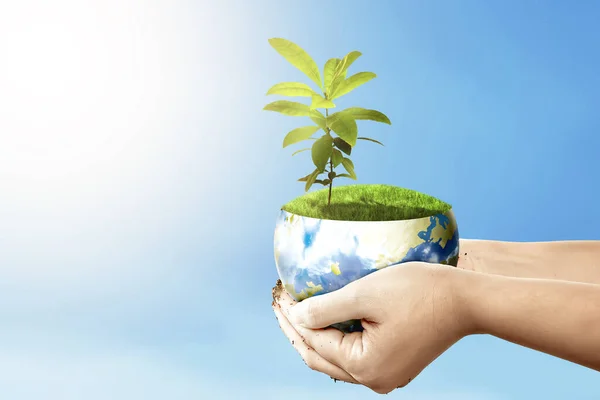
458, 239, 600, 284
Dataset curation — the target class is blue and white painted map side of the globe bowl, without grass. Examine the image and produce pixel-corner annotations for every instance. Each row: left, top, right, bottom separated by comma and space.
274, 210, 459, 301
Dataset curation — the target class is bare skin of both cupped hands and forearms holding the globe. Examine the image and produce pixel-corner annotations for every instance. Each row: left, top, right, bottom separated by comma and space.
273, 241, 600, 393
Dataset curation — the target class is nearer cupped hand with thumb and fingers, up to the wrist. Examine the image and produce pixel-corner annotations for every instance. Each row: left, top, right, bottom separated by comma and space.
273, 262, 471, 393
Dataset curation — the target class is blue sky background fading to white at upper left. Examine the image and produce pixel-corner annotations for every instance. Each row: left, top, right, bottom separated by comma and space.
0, 0, 600, 400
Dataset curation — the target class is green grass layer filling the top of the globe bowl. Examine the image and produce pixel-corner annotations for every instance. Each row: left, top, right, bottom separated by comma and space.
281, 185, 452, 221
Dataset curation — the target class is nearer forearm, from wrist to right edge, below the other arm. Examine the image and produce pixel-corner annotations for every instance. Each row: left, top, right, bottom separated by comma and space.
456, 271, 600, 371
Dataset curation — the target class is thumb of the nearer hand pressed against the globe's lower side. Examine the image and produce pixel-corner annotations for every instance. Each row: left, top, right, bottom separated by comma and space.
289, 286, 368, 329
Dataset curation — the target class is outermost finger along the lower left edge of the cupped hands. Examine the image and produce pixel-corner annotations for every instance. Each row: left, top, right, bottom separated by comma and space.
273, 306, 358, 383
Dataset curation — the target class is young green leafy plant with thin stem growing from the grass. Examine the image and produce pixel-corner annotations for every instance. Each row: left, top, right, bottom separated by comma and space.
264, 38, 392, 205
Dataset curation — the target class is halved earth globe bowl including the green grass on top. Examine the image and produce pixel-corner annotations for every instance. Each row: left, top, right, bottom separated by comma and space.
274, 185, 459, 332
